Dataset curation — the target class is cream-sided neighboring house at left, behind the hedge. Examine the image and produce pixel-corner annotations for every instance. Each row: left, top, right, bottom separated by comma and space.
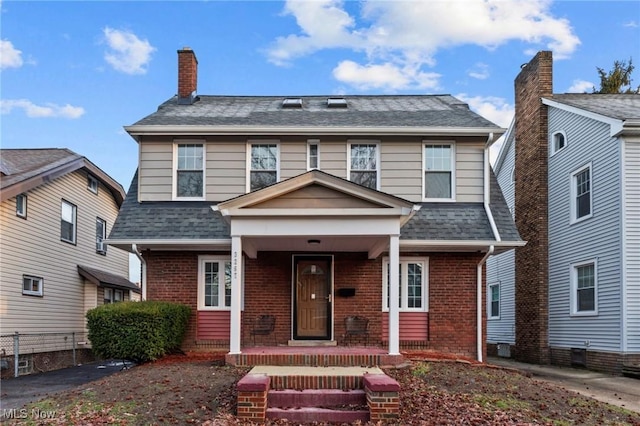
0, 149, 140, 373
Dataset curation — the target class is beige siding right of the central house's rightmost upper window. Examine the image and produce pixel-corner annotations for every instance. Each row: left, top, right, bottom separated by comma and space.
456, 143, 484, 203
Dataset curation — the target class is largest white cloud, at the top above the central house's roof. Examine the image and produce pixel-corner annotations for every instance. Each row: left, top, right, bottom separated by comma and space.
267, 0, 580, 89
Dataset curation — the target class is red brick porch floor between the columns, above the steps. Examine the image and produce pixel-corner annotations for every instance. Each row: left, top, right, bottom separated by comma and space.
225, 346, 405, 367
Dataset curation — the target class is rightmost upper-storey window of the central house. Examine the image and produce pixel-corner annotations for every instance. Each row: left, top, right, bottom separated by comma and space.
424, 144, 455, 199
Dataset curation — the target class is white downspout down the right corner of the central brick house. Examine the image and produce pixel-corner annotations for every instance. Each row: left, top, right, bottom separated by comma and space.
476, 133, 501, 362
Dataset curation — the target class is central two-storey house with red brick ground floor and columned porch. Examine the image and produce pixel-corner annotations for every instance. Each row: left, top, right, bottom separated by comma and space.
109, 48, 524, 359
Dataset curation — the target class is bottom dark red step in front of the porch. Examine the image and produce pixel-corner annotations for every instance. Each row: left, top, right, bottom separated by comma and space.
267, 407, 369, 423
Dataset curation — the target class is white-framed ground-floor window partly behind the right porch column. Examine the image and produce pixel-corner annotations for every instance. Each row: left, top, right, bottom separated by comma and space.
382, 258, 428, 311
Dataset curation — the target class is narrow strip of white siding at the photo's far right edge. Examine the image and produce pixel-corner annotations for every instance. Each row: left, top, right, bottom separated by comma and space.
624, 139, 640, 353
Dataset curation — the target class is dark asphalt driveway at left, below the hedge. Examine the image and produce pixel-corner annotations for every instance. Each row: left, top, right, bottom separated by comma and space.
0, 361, 131, 414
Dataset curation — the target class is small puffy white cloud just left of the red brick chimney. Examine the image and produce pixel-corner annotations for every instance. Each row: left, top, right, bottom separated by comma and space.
103, 27, 156, 74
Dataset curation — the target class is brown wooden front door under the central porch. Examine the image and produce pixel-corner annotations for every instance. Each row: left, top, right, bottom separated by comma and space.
294, 256, 332, 340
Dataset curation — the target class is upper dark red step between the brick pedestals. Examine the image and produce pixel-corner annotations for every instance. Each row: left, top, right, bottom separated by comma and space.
267, 389, 367, 408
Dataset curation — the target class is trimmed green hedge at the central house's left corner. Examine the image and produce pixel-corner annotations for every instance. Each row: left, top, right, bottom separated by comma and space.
87, 301, 191, 363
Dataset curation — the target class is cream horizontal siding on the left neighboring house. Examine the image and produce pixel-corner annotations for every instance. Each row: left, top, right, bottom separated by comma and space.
0, 171, 129, 334
